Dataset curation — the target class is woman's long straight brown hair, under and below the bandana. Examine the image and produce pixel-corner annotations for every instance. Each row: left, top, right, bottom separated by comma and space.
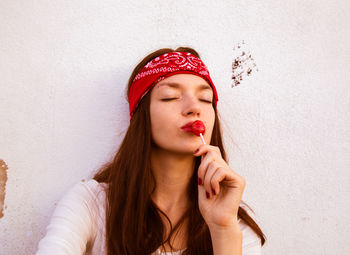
94, 47, 265, 255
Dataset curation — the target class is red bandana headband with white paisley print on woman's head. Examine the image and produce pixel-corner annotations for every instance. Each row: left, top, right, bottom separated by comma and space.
129, 52, 218, 118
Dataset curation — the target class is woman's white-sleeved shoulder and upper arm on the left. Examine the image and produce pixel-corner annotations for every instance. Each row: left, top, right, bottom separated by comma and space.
37, 180, 105, 254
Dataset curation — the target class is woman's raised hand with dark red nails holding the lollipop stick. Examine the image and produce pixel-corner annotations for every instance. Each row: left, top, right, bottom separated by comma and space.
194, 144, 246, 228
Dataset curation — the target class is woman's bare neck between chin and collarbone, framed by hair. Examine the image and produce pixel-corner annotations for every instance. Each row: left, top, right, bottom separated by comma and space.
151, 148, 195, 213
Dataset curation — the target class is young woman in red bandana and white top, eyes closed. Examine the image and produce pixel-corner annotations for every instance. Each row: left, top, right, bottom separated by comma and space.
37, 47, 265, 255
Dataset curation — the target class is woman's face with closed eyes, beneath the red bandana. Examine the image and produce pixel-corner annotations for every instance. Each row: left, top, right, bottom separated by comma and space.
150, 74, 215, 154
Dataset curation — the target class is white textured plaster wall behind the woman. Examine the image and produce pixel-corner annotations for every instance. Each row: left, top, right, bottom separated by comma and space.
0, 0, 350, 255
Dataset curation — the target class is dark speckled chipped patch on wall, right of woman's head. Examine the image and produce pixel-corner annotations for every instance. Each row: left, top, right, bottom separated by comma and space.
232, 40, 258, 87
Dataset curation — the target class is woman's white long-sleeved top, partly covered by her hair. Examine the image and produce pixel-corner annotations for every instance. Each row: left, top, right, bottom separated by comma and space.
36, 179, 261, 255
